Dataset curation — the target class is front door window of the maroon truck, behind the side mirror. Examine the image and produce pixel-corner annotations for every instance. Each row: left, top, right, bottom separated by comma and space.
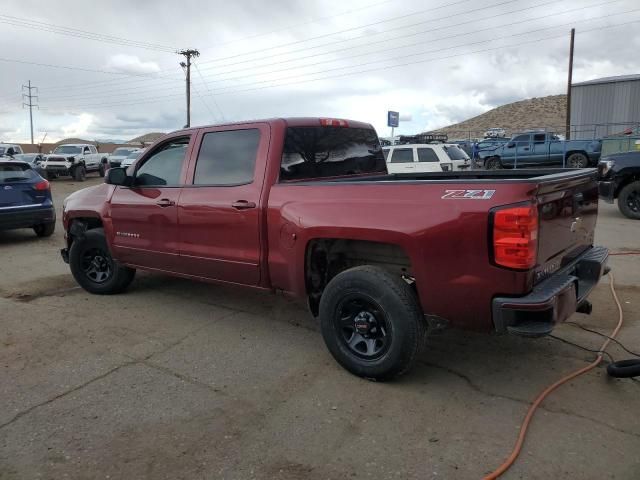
135, 138, 189, 187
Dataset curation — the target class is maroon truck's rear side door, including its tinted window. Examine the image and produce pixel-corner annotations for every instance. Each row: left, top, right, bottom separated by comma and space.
178, 124, 269, 285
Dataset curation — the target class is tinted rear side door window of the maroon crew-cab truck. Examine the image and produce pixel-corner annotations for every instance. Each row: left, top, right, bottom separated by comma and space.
193, 128, 260, 185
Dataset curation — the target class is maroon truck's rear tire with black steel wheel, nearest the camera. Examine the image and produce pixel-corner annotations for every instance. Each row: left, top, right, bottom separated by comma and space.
320, 265, 426, 380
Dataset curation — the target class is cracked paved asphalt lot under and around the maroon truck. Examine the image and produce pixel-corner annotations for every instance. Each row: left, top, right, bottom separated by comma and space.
0, 174, 640, 479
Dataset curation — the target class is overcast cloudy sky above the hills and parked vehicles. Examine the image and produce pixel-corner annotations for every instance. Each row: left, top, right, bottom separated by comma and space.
0, 0, 640, 143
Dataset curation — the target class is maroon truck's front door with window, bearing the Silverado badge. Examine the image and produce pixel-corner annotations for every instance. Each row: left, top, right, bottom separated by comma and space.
111, 137, 189, 271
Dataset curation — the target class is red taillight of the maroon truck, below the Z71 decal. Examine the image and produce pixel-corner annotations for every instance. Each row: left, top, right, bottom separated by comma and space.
493, 203, 538, 270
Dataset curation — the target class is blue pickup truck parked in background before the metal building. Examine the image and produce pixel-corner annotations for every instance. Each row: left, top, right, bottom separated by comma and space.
479, 132, 602, 170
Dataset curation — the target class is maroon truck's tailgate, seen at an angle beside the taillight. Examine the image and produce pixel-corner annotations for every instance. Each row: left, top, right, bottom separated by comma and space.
534, 169, 598, 283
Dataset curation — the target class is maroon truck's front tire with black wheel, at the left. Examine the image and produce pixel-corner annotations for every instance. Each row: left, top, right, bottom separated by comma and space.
69, 228, 136, 295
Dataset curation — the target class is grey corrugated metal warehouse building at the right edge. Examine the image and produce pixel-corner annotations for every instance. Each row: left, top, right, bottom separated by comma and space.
571, 74, 640, 139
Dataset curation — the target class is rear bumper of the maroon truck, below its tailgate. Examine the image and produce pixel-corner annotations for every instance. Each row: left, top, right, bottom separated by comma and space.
492, 247, 609, 337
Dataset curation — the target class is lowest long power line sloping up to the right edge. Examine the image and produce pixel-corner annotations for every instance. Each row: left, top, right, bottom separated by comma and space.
40, 20, 640, 108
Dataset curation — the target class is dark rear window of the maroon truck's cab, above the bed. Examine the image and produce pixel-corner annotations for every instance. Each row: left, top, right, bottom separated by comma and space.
280, 127, 387, 181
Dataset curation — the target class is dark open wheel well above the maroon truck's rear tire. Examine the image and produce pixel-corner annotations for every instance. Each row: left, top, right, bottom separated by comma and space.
305, 238, 413, 316
